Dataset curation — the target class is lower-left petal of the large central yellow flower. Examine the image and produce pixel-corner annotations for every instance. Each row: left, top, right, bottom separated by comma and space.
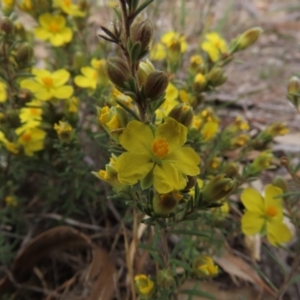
115, 152, 153, 185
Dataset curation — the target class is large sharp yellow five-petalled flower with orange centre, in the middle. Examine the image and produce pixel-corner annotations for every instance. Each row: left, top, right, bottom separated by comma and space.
115, 118, 200, 194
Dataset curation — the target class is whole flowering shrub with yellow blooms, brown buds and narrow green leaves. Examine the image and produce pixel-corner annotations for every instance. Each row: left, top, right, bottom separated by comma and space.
0, 0, 300, 299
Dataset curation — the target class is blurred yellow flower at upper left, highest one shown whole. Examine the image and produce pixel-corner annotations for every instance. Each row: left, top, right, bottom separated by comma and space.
34, 13, 73, 47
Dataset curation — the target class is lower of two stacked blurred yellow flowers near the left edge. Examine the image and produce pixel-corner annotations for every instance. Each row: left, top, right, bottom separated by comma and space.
15, 126, 46, 156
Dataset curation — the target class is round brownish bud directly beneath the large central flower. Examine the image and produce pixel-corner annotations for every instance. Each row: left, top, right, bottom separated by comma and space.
152, 192, 182, 216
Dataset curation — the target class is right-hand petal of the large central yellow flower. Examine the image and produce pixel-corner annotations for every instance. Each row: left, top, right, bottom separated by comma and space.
164, 147, 200, 176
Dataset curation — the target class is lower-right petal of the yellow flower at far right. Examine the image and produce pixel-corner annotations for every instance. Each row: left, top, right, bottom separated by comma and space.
267, 221, 292, 246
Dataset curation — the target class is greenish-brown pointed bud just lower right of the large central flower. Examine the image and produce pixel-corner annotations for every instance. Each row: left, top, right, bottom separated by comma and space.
202, 174, 236, 202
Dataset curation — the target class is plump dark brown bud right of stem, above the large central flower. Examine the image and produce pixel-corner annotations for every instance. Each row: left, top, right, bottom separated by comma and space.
144, 71, 168, 100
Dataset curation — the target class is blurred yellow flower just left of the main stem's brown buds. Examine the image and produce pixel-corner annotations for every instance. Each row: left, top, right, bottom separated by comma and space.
74, 58, 108, 90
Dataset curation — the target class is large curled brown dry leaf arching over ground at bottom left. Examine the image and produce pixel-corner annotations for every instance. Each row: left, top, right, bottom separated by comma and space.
0, 226, 115, 300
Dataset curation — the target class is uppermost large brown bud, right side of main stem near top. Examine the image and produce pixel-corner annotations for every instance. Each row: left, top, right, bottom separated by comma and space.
131, 19, 153, 52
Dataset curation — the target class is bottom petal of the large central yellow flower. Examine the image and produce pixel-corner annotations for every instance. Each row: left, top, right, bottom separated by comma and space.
153, 162, 186, 194
